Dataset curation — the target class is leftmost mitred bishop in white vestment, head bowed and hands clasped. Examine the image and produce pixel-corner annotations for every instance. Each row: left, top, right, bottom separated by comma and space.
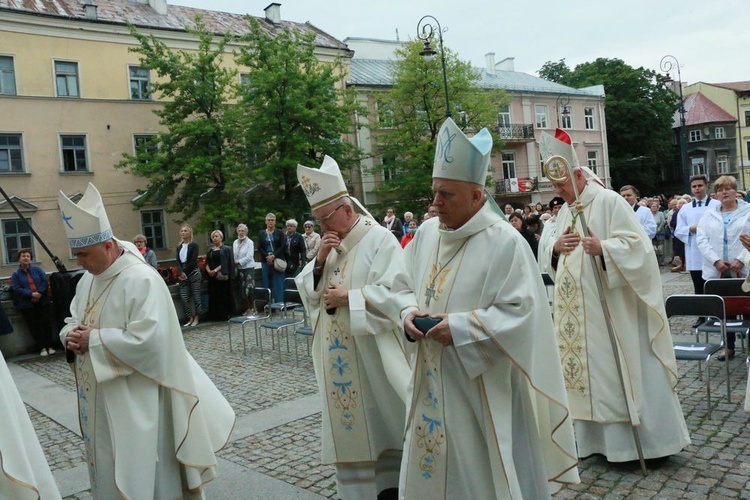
58, 184, 234, 499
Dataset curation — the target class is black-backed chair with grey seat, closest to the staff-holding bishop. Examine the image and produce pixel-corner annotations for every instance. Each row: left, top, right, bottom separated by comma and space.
664, 295, 731, 417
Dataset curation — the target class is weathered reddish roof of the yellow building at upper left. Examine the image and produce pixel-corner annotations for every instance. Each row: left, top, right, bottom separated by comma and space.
0, 0, 347, 50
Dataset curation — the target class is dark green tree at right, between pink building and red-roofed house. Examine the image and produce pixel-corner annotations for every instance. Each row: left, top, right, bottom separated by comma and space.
539, 58, 679, 193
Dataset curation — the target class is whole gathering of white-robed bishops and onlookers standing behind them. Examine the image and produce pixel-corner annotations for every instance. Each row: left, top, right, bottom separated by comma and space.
0, 122, 750, 500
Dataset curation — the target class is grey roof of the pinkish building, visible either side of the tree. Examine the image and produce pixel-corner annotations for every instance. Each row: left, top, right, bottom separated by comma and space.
348, 57, 604, 97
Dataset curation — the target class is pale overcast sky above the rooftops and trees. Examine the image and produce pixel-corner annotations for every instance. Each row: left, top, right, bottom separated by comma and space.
168, 0, 750, 83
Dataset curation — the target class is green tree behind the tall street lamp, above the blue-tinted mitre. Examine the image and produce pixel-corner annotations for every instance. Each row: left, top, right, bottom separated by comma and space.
373, 40, 508, 211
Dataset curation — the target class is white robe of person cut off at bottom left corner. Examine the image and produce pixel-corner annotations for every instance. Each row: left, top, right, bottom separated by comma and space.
0, 354, 60, 500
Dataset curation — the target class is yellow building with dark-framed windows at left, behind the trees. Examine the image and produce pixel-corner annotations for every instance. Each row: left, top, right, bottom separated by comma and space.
0, 0, 351, 277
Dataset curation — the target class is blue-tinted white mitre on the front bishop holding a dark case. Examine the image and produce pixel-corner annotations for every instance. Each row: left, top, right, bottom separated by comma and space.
432, 118, 492, 186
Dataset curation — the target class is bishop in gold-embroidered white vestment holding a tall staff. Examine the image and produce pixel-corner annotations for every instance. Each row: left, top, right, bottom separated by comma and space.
540, 131, 690, 462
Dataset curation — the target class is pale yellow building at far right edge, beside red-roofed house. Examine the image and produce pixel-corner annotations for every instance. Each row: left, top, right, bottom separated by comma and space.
683, 81, 750, 189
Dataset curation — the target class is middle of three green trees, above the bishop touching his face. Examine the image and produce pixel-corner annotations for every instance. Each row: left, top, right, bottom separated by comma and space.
237, 17, 362, 219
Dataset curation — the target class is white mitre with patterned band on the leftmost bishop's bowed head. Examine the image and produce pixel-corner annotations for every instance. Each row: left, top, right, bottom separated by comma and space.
57, 182, 112, 248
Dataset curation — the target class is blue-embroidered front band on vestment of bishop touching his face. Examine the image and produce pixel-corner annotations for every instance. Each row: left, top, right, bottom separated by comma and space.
314, 216, 378, 462
